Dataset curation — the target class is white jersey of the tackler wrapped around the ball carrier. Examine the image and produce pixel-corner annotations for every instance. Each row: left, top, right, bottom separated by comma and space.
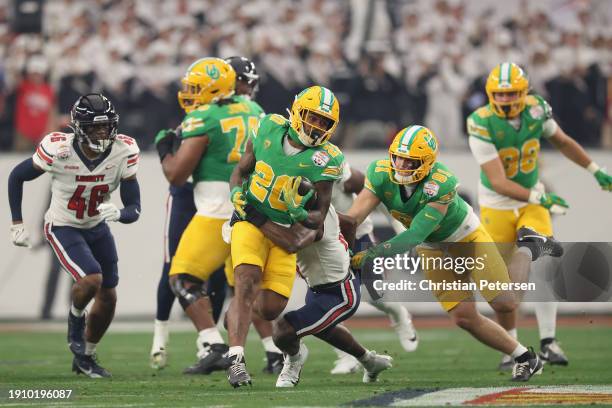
297, 205, 351, 287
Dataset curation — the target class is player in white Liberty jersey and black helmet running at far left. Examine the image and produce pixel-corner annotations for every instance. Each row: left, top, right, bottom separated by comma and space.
8, 94, 140, 378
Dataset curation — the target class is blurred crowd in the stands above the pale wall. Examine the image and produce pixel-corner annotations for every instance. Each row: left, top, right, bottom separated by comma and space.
0, 0, 612, 150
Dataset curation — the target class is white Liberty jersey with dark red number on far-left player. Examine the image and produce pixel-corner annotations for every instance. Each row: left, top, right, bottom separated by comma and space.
32, 132, 139, 228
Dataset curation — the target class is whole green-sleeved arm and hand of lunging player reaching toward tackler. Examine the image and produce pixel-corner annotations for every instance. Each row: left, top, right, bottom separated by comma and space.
351, 202, 448, 269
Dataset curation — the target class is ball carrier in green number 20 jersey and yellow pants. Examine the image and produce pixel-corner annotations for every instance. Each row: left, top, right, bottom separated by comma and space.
227, 86, 344, 387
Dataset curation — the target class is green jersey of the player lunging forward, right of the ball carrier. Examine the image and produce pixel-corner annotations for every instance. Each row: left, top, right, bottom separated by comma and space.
364, 160, 469, 242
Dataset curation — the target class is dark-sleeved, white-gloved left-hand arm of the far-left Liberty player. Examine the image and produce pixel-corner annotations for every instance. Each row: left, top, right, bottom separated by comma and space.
8, 158, 44, 247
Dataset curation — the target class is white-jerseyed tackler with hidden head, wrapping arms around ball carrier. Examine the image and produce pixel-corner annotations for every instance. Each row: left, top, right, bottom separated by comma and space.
232, 177, 392, 388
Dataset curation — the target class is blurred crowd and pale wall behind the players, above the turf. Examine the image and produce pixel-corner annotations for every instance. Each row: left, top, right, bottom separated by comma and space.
0, 0, 612, 319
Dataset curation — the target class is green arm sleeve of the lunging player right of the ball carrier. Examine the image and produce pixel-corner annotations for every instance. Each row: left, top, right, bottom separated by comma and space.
372, 205, 444, 256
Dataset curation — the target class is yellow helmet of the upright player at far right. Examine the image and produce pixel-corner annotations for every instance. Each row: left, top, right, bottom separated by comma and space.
485, 62, 529, 118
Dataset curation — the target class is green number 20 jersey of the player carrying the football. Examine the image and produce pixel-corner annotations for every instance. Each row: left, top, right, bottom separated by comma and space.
246, 115, 344, 224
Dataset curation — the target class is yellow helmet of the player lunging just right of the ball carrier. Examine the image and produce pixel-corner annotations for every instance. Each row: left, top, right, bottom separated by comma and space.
389, 125, 438, 184
